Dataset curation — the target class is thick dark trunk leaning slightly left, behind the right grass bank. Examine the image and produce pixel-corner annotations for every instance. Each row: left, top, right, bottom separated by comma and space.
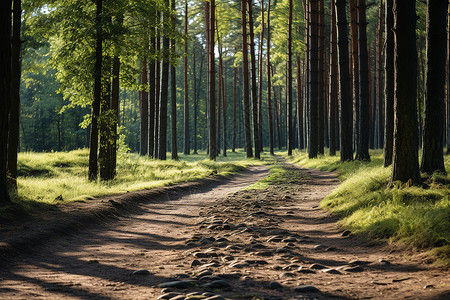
336, 0, 353, 162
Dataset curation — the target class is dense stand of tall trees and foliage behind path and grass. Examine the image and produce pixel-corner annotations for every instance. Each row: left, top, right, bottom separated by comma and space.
2, 0, 450, 204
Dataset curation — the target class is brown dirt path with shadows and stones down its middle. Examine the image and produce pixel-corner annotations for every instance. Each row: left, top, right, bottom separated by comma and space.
0, 160, 450, 299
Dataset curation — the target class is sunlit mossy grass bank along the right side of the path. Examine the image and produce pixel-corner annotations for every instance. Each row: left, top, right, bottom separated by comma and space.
291, 151, 450, 266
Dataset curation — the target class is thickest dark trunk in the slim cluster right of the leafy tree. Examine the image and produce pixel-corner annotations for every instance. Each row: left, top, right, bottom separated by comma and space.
158, 5, 170, 160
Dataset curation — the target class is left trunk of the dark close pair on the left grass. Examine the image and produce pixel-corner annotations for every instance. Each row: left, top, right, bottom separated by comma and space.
88, 0, 103, 181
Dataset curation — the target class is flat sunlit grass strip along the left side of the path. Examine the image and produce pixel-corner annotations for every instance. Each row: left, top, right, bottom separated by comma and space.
6, 149, 260, 215
